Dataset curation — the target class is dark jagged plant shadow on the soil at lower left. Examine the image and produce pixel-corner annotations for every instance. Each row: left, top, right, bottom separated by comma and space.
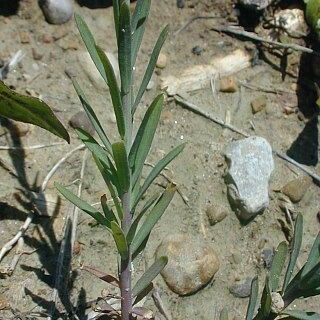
0, 118, 86, 319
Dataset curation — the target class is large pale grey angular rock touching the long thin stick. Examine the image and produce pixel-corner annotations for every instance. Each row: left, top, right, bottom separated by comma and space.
225, 137, 274, 220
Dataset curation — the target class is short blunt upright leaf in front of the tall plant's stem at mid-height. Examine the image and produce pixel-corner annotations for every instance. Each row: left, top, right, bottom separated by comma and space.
112, 141, 130, 196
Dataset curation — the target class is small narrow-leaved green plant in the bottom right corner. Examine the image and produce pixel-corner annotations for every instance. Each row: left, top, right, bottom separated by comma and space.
246, 214, 320, 320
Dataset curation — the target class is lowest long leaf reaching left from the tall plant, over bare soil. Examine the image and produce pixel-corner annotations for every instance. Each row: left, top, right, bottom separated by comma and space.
54, 182, 110, 230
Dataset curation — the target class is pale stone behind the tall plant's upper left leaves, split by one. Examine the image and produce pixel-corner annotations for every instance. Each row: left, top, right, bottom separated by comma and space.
78, 51, 120, 89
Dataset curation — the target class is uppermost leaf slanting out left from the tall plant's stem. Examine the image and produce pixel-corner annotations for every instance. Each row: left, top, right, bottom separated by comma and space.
74, 13, 108, 83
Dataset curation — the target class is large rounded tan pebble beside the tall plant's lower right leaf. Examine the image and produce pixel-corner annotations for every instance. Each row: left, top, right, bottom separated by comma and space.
156, 234, 220, 295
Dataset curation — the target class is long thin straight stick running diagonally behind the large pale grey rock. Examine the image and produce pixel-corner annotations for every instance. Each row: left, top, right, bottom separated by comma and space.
174, 95, 320, 183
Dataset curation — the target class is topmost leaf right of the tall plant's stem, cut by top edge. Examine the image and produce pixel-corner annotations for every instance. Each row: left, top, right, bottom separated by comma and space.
131, 0, 151, 66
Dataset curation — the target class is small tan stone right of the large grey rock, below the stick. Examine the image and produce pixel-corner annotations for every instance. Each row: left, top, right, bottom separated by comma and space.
281, 175, 312, 203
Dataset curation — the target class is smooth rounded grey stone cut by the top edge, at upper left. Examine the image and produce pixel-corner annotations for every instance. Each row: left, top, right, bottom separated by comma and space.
39, 0, 73, 24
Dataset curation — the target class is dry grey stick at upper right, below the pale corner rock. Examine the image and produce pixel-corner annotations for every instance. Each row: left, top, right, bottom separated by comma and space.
211, 26, 320, 56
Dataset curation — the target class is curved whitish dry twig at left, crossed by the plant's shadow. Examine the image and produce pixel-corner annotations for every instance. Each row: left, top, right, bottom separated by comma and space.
0, 145, 85, 262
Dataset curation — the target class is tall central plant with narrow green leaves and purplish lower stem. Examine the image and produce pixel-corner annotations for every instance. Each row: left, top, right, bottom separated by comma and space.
56, 0, 184, 320
